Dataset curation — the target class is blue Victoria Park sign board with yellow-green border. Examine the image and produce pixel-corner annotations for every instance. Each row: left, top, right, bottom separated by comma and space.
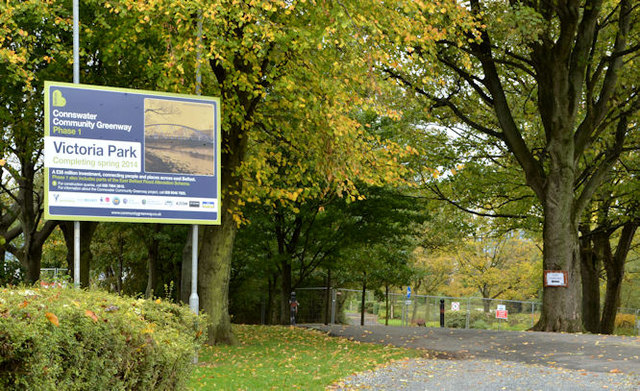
44, 82, 220, 224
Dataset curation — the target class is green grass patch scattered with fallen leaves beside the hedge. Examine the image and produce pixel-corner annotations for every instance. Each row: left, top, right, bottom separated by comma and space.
189, 325, 422, 390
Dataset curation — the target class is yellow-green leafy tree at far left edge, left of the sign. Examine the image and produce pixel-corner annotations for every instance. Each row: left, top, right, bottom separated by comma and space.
0, 1, 69, 283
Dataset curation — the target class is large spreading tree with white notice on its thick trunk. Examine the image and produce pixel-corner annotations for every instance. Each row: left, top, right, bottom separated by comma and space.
384, 0, 640, 332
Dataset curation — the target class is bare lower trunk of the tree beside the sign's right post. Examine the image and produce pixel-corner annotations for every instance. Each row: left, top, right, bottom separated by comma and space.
198, 207, 238, 345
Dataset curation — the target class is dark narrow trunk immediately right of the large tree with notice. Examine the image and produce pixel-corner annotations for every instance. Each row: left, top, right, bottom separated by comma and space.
580, 224, 601, 333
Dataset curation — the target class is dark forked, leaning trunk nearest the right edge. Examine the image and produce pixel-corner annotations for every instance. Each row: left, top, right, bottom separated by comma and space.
599, 222, 638, 334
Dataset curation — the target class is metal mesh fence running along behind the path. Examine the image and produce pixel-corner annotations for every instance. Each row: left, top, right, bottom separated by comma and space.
296, 287, 640, 335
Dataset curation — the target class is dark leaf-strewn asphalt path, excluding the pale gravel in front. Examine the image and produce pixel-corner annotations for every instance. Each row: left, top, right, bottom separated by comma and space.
304, 324, 640, 374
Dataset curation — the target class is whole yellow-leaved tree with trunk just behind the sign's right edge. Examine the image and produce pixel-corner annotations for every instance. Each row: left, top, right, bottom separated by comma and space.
138, 1, 416, 343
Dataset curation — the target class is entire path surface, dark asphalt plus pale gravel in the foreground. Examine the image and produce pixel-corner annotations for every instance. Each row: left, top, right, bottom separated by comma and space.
305, 325, 640, 391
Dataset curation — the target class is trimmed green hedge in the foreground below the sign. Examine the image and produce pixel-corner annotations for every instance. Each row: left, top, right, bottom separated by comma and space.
0, 288, 205, 390
